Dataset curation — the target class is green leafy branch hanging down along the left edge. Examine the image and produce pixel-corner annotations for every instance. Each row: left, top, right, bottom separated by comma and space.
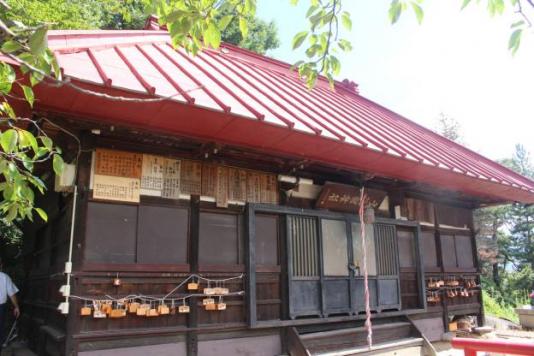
0, 2, 63, 221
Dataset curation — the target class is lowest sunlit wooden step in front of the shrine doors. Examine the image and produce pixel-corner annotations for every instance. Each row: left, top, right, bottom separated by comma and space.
311, 337, 423, 356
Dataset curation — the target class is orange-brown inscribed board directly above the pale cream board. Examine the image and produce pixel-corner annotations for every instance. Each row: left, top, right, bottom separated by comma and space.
95, 148, 143, 179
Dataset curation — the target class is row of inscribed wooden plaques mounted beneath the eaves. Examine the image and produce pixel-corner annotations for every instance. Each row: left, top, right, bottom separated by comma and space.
91, 148, 278, 207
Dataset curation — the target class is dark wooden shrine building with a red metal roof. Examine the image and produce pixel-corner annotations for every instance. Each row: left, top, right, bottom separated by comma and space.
5, 18, 534, 356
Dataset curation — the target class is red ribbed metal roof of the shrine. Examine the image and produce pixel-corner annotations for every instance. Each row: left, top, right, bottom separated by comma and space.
23, 30, 534, 203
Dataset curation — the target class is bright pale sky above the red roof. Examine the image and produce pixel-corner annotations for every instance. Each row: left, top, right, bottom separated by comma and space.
257, 0, 534, 159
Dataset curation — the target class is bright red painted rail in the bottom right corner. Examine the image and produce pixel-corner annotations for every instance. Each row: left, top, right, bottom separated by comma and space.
452, 338, 534, 356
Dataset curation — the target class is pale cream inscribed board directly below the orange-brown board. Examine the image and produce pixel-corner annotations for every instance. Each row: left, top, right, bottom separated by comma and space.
93, 174, 141, 203
